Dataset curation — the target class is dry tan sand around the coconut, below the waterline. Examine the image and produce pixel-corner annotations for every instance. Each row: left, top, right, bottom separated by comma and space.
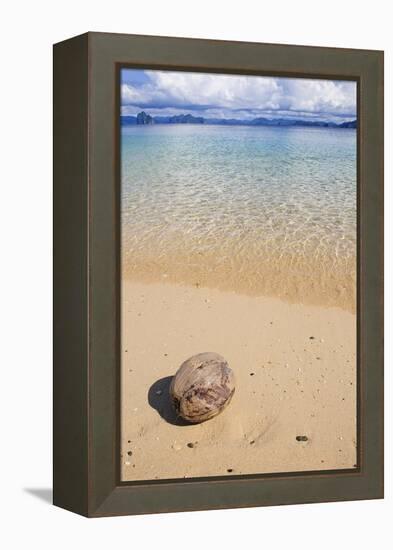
121, 278, 356, 481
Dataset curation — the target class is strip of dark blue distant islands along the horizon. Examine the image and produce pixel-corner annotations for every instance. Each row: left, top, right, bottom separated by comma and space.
121, 111, 357, 128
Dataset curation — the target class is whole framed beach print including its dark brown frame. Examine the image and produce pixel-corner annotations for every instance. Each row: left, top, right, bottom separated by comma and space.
54, 33, 383, 517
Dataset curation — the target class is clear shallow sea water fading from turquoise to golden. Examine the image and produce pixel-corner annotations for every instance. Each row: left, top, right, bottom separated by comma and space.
121, 124, 356, 310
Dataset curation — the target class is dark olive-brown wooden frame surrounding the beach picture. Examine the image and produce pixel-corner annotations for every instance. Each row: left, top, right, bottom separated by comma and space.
53, 33, 383, 517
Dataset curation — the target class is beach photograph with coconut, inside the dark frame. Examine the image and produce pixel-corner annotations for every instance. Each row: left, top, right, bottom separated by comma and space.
119, 68, 357, 482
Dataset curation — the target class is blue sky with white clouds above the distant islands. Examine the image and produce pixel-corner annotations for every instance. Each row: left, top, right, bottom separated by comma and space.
121, 69, 356, 122
